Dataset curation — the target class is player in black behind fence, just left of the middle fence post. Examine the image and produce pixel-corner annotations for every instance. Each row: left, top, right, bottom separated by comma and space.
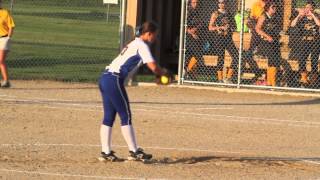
208, 0, 239, 84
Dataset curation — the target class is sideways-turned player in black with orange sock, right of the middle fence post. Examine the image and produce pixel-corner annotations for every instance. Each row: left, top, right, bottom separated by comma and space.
255, 2, 281, 86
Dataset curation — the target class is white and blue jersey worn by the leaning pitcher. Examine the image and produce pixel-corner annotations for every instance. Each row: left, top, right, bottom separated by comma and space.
106, 38, 154, 78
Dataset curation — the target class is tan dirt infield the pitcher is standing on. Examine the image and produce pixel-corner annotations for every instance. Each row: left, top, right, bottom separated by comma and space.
0, 81, 320, 179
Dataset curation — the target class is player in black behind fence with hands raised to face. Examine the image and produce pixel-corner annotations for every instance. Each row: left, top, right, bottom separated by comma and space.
291, 1, 320, 87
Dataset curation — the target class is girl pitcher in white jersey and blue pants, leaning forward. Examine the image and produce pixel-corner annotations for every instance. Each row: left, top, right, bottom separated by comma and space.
99, 22, 163, 161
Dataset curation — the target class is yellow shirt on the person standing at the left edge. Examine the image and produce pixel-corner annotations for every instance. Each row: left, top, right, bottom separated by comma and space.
0, 9, 15, 36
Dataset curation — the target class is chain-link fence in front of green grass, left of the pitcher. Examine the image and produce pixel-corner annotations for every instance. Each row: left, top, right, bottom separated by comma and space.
3, 0, 120, 81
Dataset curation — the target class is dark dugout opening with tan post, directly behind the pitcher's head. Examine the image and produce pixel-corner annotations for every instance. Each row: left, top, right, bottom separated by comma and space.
123, 0, 181, 72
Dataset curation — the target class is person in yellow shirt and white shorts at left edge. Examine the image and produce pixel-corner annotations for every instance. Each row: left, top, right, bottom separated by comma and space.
0, 0, 15, 88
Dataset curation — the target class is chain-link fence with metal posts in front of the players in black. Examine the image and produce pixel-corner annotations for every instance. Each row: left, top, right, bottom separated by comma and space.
182, 0, 320, 91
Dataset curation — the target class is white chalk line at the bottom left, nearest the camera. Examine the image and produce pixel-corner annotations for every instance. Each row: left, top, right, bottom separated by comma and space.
0, 169, 150, 180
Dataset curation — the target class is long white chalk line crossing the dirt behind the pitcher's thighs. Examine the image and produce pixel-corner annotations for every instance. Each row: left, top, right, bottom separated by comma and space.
0, 95, 320, 128
